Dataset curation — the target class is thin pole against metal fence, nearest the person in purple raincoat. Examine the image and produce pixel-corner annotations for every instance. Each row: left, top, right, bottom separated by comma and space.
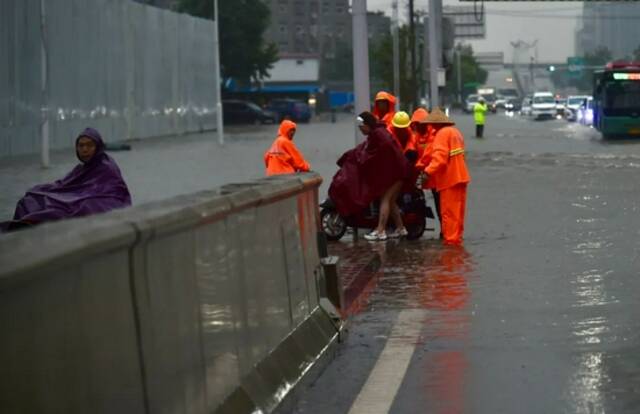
40, 0, 50, 168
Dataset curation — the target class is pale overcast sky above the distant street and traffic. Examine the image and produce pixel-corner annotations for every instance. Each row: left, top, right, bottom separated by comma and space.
367, 0, 582, 62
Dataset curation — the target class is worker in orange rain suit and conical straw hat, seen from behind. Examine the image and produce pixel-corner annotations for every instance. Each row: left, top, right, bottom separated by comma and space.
424, 108, 471, 245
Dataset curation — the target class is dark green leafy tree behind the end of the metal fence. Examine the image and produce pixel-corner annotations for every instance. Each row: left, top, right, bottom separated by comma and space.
178, 0, 278, 84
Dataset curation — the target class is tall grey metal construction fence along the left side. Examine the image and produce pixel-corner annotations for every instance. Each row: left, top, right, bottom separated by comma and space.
0, 0, 216, 158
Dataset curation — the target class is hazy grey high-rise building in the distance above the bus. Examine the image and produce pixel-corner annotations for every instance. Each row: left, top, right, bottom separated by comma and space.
576, 2, 640, 59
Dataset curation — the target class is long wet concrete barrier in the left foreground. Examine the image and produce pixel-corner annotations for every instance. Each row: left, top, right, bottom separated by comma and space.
0, 174, 339, 414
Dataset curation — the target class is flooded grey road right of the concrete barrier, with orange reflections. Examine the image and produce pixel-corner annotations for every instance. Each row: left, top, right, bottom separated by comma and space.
293, 115, 640, 413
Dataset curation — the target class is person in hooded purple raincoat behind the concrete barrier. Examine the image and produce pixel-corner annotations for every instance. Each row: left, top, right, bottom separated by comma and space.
1, 128, 131, 231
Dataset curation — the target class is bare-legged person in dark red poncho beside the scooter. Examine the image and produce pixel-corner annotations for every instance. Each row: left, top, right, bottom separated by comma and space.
329, 112, 411, 240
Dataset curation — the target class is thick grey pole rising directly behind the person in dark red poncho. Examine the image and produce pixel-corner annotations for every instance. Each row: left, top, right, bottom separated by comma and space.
351, 0, 370, 145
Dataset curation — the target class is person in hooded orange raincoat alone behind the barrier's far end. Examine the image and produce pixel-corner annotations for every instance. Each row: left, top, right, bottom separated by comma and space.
264, 119, 311, 175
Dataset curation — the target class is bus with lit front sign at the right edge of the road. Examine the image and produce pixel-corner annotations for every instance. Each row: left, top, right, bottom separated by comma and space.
593, 62, 640, 138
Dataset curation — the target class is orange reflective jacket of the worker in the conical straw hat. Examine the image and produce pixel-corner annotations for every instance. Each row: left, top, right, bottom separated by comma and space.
424, 126, 471, 191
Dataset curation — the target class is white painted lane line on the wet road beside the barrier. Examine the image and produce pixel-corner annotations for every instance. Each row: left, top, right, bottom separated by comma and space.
349, 309, 427, 414
